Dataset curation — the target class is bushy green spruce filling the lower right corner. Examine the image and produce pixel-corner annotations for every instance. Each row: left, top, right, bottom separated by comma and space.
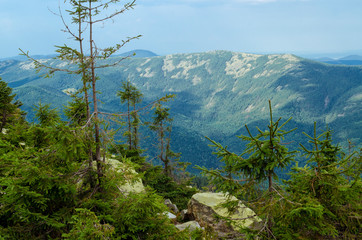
277, 124, 362, 239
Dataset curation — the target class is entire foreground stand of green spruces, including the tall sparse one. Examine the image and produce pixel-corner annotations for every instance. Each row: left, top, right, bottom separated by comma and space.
0, 0, 362, 239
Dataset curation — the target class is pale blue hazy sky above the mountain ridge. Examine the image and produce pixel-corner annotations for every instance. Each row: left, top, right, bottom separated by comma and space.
0, 0, 362, 58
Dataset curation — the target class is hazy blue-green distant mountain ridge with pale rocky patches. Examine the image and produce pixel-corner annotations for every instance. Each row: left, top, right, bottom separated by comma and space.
0, 51, 362, 171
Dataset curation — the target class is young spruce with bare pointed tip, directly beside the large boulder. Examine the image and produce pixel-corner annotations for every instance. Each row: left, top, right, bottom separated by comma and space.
198, 101, 295, 238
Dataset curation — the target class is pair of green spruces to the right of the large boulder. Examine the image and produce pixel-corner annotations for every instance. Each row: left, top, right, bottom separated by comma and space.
199, 103, 362, 239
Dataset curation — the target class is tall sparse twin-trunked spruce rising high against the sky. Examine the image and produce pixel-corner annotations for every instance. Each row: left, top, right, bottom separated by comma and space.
22, 0, 140, 190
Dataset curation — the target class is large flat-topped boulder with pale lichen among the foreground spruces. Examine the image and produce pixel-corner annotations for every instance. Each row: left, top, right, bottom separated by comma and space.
188, 192, 261, 239
